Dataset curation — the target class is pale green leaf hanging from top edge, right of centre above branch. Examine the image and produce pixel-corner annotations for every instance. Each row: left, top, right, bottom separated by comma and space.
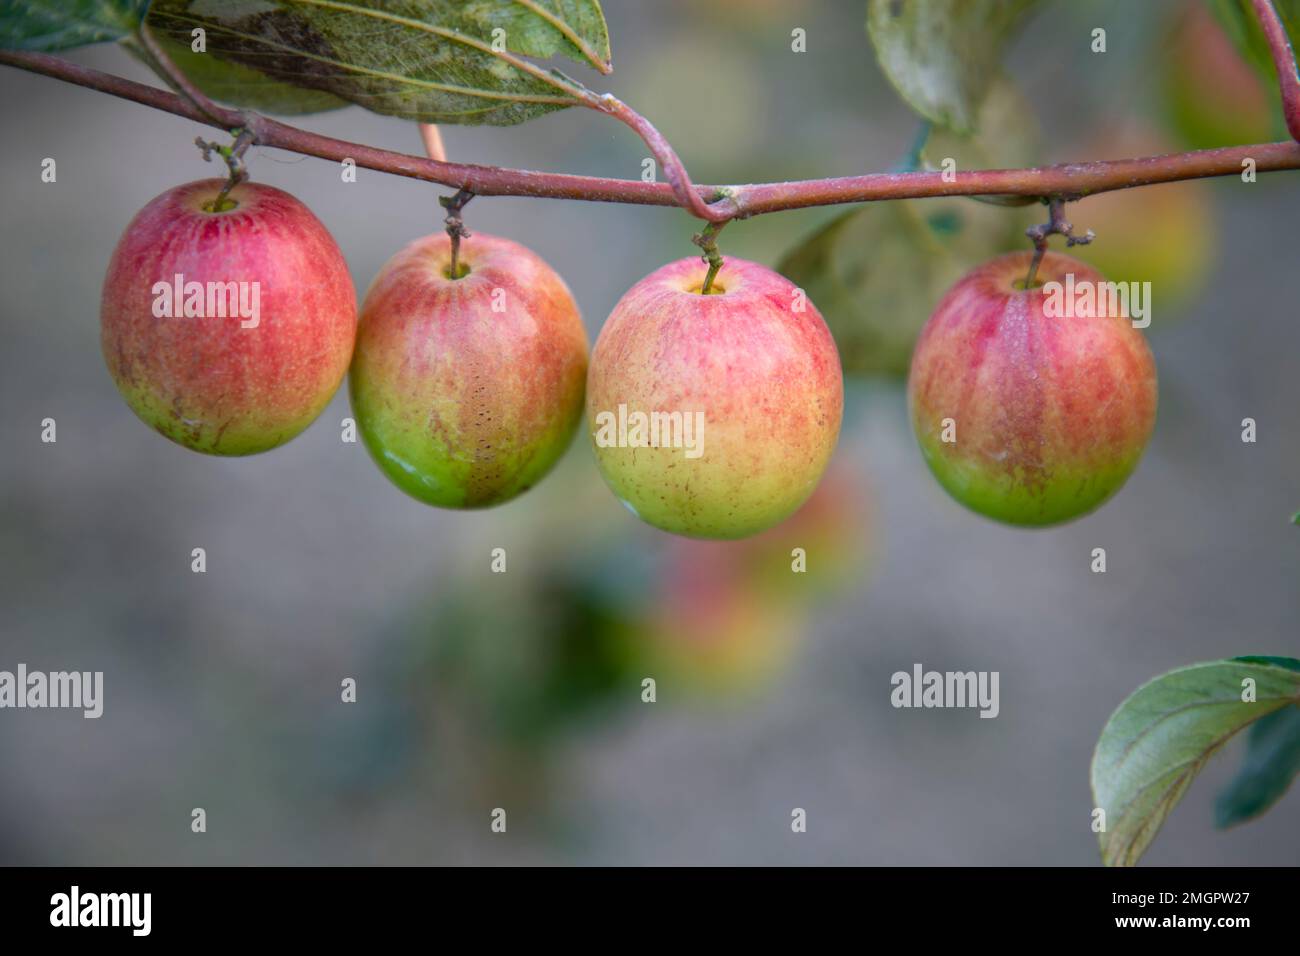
867, 0, 1039, 134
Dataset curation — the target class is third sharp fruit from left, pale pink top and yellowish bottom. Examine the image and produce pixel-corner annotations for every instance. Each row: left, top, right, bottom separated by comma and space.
586, 258, 844, 538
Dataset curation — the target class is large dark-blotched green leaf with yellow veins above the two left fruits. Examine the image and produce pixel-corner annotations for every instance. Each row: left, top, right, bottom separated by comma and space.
148, 0, 610, 126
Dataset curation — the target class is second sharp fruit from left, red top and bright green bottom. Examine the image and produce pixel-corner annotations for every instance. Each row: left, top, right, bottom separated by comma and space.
348, 233, 586, 507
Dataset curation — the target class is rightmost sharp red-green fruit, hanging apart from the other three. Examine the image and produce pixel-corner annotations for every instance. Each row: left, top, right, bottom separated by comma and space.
907, 252, 1156, 525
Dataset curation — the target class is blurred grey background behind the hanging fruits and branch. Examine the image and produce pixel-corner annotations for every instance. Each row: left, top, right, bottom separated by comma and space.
0, 0, 1300, 865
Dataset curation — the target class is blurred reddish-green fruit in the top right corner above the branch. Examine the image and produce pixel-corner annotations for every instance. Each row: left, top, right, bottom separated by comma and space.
1161, 3, 1286, 150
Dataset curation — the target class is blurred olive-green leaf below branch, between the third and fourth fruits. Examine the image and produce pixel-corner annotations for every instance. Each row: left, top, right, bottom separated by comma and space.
776, 198, 1027, 377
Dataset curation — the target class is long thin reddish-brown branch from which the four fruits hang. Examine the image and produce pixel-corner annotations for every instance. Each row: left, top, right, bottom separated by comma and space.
0, 51, 1300, 221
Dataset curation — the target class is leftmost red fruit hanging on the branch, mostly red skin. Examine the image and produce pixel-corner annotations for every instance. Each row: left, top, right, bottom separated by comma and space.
100, 179, 356, 455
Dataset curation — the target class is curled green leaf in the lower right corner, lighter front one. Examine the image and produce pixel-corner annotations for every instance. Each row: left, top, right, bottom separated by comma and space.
1092, 658, 1300, 866
